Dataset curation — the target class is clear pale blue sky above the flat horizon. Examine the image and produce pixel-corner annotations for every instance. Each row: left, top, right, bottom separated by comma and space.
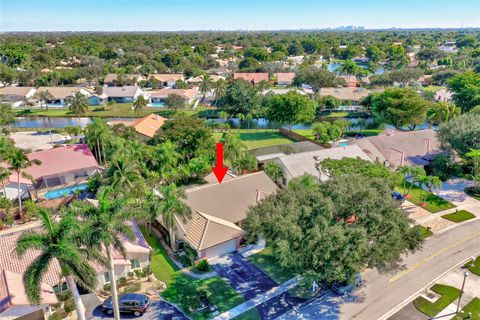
0, 0, 480, 31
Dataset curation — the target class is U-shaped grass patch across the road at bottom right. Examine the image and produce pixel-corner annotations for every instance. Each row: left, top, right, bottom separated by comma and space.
413, 284, 460, 317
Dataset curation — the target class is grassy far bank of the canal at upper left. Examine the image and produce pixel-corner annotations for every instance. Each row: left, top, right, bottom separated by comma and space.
15, 103, 204, 118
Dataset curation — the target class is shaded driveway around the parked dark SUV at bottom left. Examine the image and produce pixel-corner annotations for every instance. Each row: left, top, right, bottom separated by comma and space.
90, 300, 190, 320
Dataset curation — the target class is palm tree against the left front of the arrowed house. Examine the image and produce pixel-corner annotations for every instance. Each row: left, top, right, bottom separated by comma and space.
158, 183, 191, 248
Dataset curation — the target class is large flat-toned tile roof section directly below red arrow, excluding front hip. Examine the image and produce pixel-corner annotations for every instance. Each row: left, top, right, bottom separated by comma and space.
182, 171, 278, 223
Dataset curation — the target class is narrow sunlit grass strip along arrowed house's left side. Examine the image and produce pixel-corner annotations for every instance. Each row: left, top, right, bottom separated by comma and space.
140, 226, 178, 285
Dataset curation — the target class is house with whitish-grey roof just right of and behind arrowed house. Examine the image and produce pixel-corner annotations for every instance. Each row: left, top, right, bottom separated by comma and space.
268, 145, 370, 185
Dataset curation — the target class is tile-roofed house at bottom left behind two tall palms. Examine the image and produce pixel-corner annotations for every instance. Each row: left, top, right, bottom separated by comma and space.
0, 221, 151, 320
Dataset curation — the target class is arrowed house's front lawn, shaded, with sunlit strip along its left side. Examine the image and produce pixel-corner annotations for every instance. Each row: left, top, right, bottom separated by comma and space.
140, 227, 260, 320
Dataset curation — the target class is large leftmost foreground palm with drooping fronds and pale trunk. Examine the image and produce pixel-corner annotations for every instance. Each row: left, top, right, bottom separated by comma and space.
16, 208, 97, 320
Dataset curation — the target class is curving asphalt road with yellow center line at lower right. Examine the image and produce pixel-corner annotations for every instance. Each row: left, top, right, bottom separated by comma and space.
280, 220, 480, 320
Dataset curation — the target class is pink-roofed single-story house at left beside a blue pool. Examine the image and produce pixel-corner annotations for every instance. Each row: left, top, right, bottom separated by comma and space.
0, 144, 101, 200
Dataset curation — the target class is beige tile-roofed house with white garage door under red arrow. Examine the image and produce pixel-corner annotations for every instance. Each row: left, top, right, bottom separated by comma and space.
157, 171, 278, 259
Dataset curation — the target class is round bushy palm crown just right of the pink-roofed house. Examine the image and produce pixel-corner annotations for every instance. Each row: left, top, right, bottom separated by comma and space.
105, 156, 141, 194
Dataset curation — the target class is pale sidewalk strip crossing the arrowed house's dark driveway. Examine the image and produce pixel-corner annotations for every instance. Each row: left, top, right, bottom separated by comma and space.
214, 277, 300, 320
